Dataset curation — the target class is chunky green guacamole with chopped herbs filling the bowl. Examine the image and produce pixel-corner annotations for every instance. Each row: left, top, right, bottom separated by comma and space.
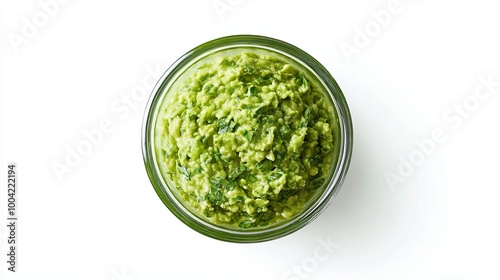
155, 50, 338, 228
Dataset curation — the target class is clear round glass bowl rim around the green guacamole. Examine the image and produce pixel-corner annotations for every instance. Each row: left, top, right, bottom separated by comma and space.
142, 35, 353, 243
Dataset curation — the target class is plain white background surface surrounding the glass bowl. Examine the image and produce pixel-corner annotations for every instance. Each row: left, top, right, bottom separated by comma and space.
0, 0, 500, 280
